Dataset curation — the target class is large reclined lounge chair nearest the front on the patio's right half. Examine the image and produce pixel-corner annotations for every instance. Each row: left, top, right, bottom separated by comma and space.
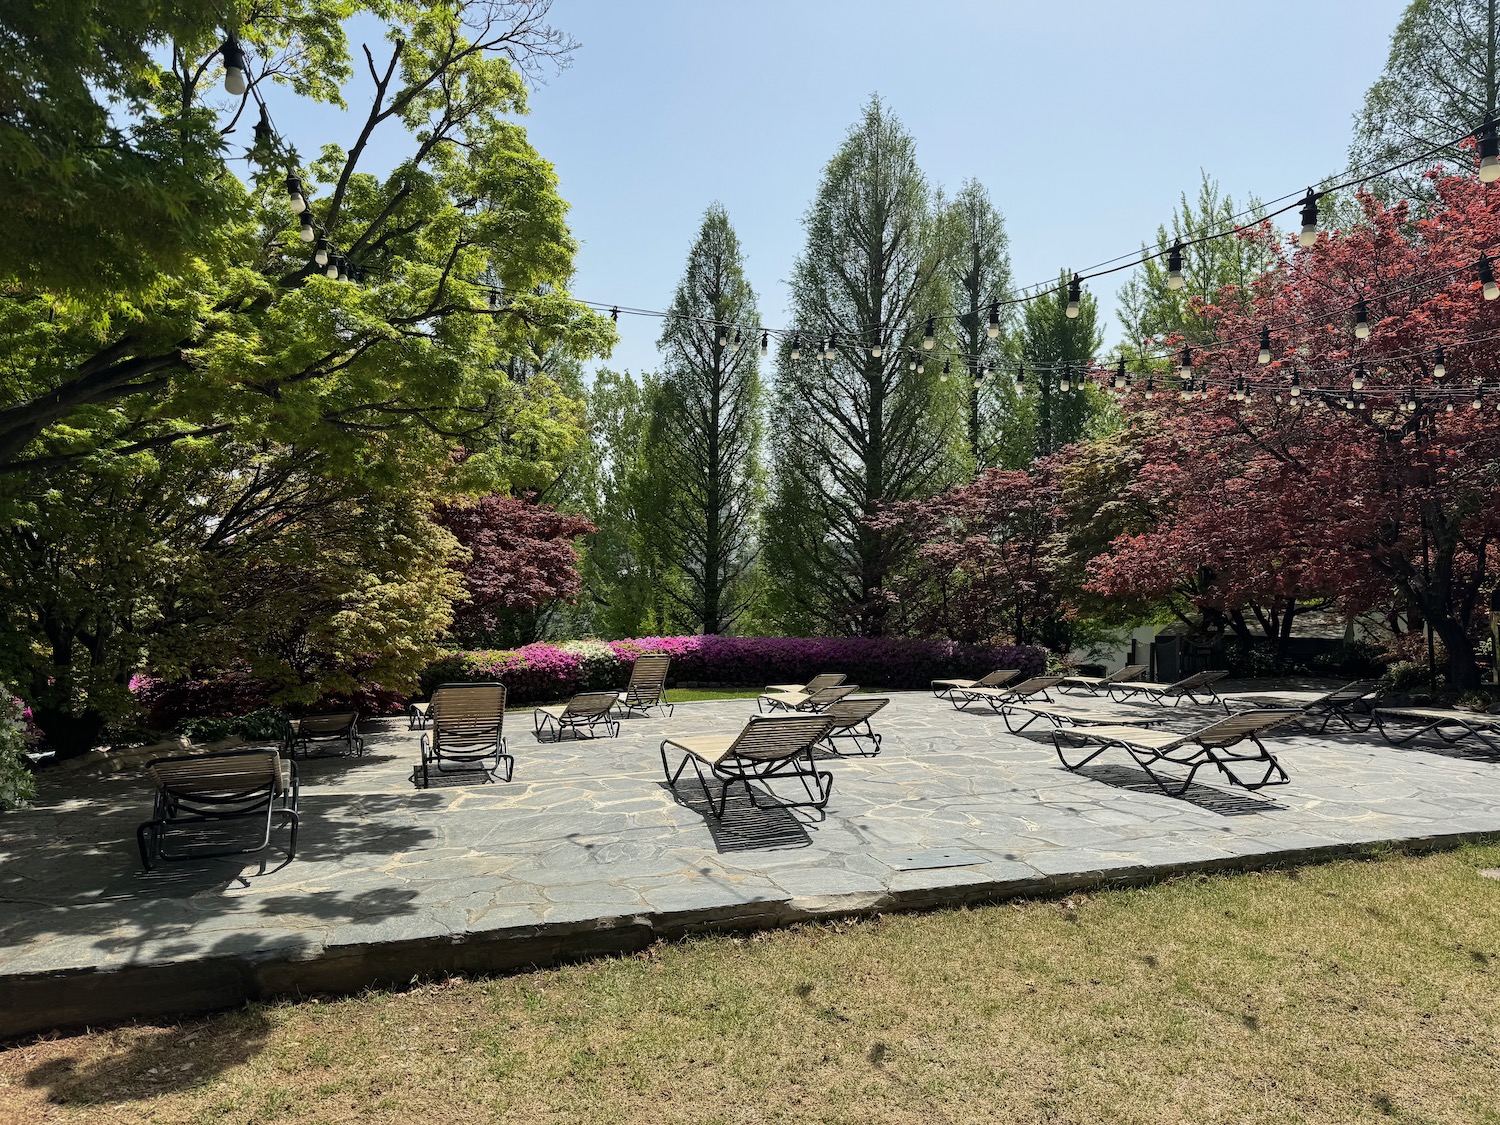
1052, 707, 1302, 797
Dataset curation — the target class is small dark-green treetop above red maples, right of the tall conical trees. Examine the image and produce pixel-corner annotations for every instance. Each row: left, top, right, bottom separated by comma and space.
1013, 270, 1107, 458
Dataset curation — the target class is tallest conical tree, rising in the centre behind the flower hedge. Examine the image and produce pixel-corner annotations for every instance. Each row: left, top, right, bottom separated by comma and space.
767, 99, 963, 635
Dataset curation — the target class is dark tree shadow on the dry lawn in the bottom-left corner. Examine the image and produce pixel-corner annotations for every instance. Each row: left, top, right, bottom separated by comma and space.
21, 1008, 275, 1106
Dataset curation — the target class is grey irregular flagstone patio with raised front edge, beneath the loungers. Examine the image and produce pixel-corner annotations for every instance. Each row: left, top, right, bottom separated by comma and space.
0, 678, 1500, 1037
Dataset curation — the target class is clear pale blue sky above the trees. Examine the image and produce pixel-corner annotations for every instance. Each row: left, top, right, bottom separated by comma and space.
270, 0, 1406, 379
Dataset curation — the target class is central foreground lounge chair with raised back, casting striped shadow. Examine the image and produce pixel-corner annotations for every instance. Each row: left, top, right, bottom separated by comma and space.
662, 714, 834, 819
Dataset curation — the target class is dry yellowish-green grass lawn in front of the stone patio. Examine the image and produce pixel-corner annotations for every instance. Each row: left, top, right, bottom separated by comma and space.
0, 846, 1500, 1125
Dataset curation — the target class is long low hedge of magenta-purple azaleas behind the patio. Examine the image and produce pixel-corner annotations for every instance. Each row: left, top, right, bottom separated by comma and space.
422, 636, 1047, 704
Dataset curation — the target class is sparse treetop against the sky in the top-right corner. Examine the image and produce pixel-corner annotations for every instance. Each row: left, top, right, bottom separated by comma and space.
1349, 0, 1500, 201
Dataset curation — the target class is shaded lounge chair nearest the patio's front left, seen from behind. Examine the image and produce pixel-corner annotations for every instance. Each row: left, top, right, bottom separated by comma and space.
135, 750, 297, 872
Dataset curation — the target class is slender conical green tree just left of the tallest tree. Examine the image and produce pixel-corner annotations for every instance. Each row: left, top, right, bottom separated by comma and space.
653, 204, 764, 633
